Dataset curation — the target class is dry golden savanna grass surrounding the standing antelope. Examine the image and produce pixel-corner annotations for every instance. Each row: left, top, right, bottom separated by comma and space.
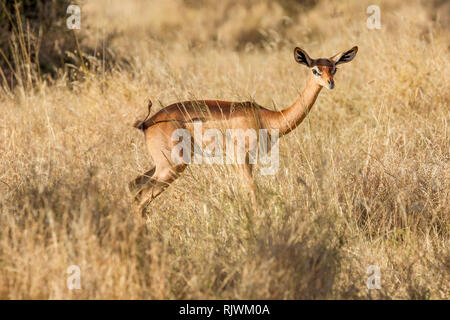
0, 0, 450, 299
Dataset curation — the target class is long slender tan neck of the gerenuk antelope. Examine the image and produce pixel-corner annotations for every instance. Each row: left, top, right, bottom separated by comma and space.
269, 76, 322, 136
